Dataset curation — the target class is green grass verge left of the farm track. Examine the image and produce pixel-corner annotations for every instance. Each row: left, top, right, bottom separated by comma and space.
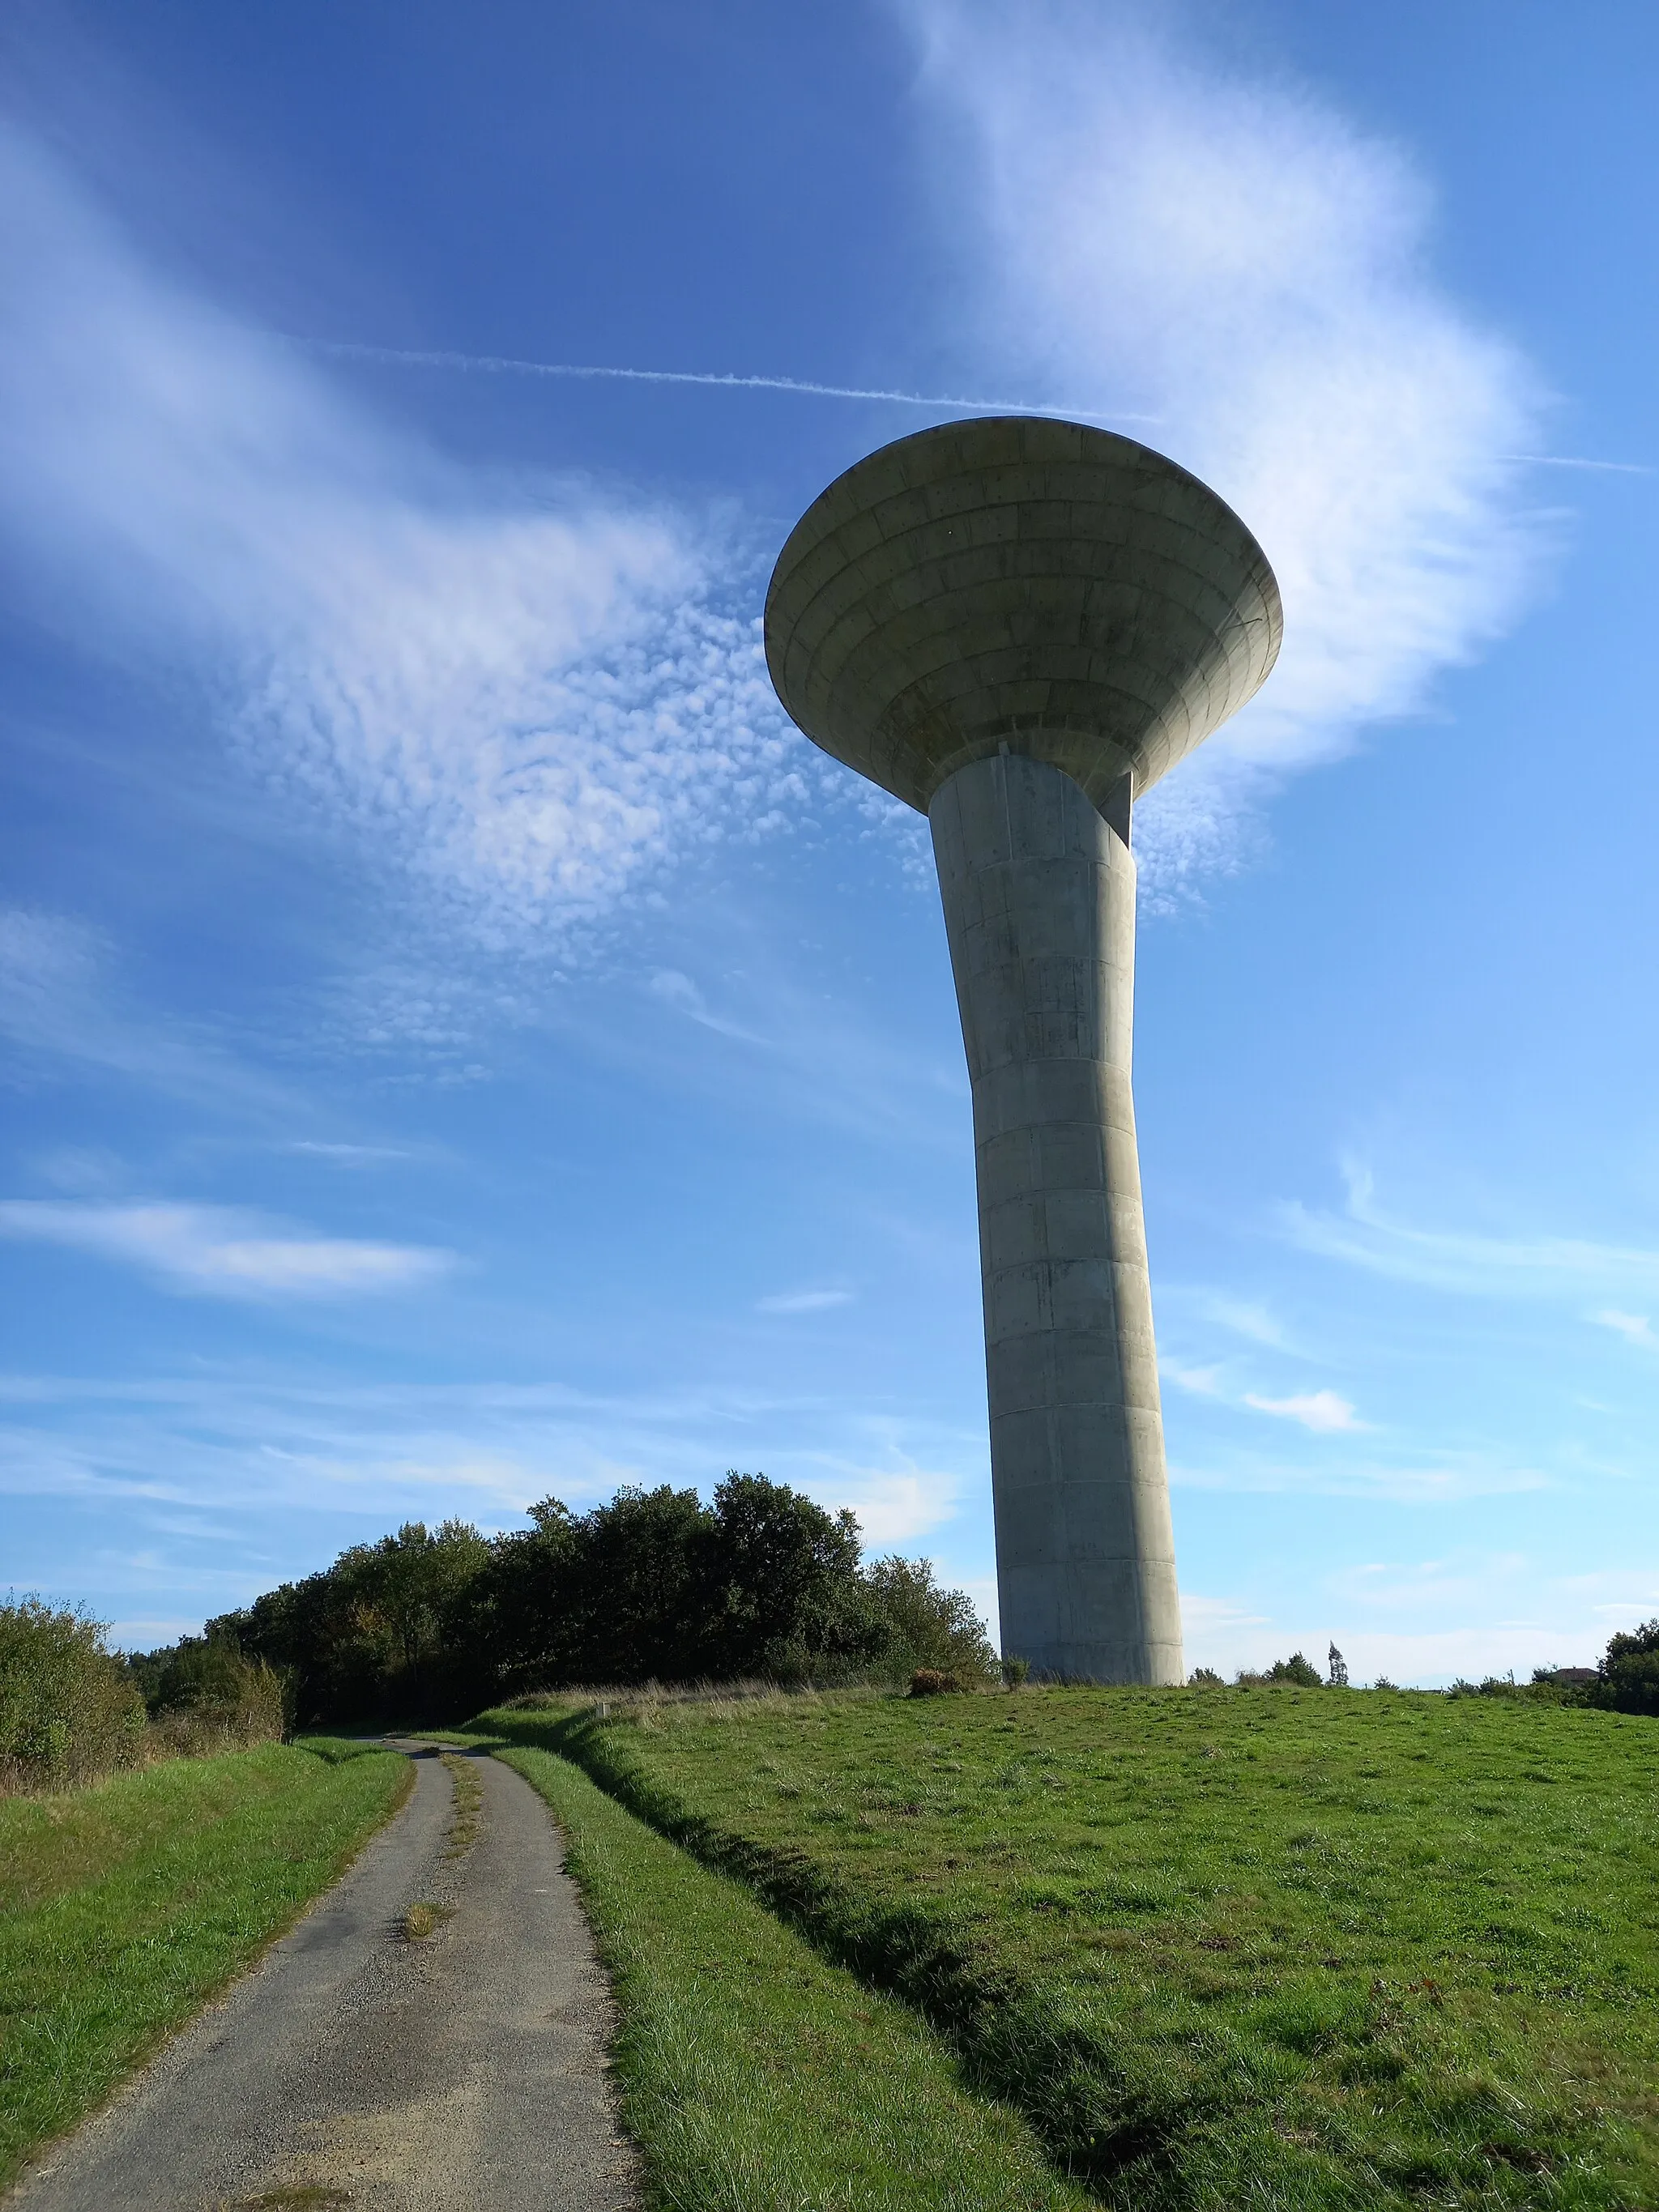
0, 1741, 412, 2188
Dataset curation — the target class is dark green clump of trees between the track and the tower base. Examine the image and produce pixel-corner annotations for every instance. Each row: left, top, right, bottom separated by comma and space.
204, 1473, 1013, 1698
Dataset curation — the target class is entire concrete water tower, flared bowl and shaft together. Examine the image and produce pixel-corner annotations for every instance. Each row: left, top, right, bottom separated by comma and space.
766, 416, 1281, 1683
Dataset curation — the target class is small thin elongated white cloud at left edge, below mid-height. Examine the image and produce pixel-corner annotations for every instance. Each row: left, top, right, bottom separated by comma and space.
0, 1199, 454, 1298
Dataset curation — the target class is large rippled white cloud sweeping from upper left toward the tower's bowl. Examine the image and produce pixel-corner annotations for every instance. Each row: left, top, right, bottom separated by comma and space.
0, 128, 818, 942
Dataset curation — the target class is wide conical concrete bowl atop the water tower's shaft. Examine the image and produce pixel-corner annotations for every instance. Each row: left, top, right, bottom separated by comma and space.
766, 416, 1283, 812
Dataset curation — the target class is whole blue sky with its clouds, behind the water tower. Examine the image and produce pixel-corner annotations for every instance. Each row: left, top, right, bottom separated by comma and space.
0, 0, 1659, 1681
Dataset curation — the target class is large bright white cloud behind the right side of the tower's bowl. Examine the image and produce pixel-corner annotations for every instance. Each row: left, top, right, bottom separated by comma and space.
893, 0, 1537, 883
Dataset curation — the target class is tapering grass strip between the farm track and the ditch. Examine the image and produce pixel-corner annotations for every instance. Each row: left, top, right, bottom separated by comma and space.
471, 1747, 1106, 2212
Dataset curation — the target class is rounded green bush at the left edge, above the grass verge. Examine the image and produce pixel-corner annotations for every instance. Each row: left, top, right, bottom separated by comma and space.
0, 1597, 143, 1789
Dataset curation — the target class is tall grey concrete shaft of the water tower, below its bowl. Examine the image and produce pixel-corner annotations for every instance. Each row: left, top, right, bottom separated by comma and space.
929, 754, 1186, 1681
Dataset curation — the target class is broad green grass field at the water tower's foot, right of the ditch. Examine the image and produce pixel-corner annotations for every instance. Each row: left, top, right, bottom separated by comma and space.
488, 1690, 1659, 2212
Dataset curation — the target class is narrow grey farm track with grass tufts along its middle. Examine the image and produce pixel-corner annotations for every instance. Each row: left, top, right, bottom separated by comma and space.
6, 1745, 637, 2212
